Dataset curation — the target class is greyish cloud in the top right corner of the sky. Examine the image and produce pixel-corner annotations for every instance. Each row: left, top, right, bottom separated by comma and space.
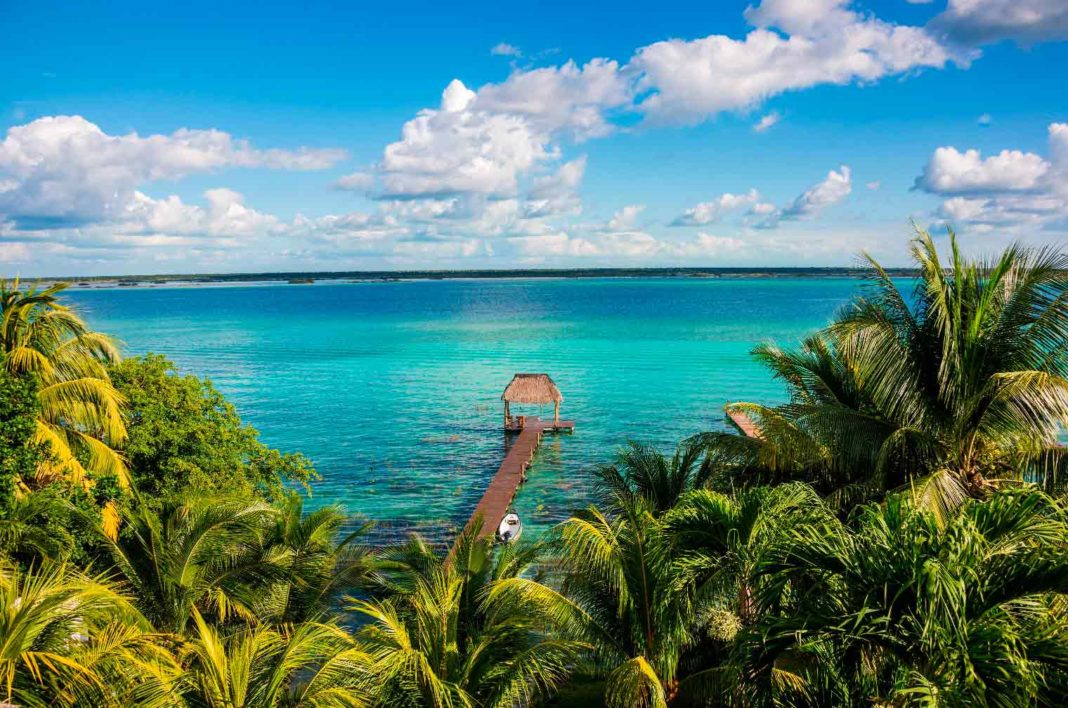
931, 0, 1068, 45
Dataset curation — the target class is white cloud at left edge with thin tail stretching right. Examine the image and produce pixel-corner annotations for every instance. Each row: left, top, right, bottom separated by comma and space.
0, 115, 345, 225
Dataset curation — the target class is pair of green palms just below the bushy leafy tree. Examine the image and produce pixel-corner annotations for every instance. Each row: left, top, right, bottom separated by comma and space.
101, 495, 373, 633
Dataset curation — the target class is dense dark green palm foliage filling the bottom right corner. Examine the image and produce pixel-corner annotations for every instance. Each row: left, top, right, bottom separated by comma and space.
738, 490, 1068, 706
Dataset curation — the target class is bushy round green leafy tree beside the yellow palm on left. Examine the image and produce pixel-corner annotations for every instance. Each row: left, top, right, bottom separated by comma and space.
111, 355, 315, 503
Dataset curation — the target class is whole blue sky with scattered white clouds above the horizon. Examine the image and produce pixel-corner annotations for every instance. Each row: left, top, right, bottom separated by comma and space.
0, 0, 1068, 277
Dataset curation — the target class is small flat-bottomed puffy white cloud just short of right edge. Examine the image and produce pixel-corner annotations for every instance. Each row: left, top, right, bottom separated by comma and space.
916, 147, 1050, 194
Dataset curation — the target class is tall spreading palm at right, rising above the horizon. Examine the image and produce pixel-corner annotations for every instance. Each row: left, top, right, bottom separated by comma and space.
703, 231, 1068, 514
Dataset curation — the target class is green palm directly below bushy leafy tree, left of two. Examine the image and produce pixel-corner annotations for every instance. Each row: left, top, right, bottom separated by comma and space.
100, 498, 288, 634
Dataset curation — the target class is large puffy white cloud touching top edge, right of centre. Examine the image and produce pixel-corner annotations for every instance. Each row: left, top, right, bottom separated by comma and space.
630, 0, 956, 123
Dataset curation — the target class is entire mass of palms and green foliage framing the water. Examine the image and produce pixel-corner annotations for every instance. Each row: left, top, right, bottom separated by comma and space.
0, 233, 1068, 708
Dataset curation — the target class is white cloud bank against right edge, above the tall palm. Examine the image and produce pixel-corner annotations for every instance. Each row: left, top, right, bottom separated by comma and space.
915, 123, 1068, 231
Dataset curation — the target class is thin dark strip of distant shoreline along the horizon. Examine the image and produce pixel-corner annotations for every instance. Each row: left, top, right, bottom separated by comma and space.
41, 267, 916, 288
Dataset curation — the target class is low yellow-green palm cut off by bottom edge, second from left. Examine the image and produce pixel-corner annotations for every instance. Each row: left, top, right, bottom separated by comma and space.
184, 610, 366, 708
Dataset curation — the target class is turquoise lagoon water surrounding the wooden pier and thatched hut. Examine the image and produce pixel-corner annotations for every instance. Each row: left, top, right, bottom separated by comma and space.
70, 279, 859, 537
